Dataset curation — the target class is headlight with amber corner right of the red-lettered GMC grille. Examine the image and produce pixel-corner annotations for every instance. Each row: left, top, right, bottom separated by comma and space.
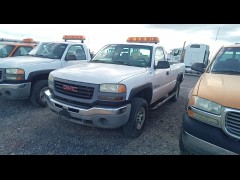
100, 84, 127, 93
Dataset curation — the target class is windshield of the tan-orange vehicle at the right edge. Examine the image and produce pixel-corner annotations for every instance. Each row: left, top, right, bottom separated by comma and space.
207, 47, 240, 74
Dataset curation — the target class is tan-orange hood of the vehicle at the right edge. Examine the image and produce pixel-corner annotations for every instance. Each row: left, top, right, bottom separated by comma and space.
197, 73, 240, 109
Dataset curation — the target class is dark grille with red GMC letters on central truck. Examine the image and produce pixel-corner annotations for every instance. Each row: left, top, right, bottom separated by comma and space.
54, 81, 94, 99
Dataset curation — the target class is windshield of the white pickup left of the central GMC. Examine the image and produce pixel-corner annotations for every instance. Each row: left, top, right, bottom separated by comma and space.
28, 43, 67, 59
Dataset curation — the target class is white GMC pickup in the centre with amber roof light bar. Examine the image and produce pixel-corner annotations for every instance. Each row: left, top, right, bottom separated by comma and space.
45, 37, 185, 137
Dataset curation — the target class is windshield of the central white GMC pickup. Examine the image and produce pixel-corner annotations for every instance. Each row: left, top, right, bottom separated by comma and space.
90, 44, 153, 67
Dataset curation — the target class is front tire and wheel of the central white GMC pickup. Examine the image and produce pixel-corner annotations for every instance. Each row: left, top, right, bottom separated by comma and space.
122, 98, 148, 138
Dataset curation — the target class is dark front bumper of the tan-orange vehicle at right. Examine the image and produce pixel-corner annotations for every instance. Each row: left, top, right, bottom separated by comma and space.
180, 114, 240, 155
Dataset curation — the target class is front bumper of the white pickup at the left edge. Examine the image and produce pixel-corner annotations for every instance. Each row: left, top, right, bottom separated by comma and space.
0, 82, 31, 100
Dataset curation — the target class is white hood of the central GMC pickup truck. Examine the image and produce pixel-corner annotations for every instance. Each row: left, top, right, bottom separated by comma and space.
51, 62, 147, 84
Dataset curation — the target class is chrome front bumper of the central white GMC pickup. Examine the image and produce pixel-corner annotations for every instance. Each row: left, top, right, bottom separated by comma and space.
44, 90, 131, 129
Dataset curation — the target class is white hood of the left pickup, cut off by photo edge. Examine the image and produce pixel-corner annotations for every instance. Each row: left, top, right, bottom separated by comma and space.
0, 56, 54, 68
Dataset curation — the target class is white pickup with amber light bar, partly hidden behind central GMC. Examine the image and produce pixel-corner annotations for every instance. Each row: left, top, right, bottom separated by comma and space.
0, 36, 91, 106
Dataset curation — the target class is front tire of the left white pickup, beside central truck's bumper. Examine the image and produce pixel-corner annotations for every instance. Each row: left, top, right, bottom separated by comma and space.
30, 80, 48, 107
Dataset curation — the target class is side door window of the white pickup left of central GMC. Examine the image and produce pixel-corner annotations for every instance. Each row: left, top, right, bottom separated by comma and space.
65, 45, 87, 60
